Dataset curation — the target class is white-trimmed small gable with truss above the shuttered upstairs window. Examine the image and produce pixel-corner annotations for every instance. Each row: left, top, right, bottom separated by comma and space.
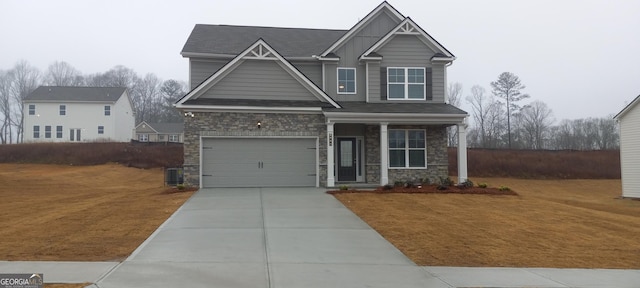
360, 18, 455, 61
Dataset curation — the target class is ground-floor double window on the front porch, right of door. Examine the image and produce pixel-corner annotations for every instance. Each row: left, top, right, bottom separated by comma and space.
389, 129, 427, 168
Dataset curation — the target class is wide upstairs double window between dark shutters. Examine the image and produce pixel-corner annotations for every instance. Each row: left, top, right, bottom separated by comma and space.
387, 67, 426, 100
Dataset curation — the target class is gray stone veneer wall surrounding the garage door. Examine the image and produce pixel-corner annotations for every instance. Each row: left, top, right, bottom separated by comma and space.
184, 112, 327, 186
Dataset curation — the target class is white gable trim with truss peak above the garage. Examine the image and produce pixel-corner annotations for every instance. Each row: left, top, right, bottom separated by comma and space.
176, 38, 340, 108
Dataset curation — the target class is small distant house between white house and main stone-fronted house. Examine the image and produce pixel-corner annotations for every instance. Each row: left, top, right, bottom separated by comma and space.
133, 121, 184, 143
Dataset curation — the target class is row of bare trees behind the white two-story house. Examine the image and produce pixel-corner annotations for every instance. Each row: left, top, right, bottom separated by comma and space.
0, 60, 187, 144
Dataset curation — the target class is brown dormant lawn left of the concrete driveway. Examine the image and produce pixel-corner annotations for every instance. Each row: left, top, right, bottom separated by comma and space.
0, 164, 193, 260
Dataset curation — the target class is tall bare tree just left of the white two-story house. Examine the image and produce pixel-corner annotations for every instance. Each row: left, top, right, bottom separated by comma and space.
11, 60, 40, 142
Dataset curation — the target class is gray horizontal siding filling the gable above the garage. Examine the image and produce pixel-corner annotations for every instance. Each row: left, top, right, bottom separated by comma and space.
201, 60, 318, 100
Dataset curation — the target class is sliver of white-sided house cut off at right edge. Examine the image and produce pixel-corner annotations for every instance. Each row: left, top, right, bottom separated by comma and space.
614, 96, 640, 198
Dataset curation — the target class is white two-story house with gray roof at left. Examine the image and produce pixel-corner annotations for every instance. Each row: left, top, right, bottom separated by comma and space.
23, 86, 135, 142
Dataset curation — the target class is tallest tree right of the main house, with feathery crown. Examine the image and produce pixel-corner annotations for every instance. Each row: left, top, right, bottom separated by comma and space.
491, 72, 529, 148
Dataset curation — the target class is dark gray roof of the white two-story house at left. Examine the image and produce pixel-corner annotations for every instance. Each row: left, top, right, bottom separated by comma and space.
24, 86, 127, 102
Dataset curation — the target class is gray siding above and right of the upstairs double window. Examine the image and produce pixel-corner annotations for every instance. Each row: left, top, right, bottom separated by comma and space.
380, 35, 446, 102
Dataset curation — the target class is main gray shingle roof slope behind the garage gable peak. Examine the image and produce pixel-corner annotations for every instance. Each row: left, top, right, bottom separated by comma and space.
182, 24, 347, 58
